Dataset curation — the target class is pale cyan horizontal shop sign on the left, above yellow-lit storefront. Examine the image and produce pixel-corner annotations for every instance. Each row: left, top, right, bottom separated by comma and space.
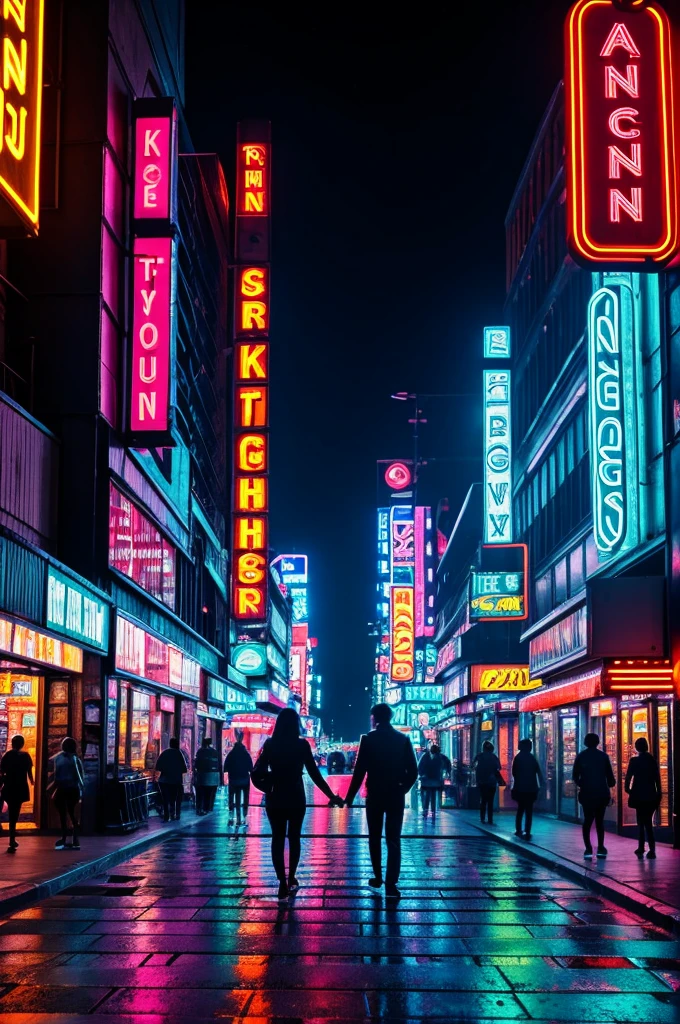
45, 565, 109, 651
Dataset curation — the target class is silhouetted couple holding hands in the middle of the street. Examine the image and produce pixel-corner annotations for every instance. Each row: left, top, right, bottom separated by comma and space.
252, 705, 418, 900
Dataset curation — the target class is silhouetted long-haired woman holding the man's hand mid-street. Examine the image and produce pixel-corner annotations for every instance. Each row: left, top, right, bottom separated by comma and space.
252, 708, 343, 901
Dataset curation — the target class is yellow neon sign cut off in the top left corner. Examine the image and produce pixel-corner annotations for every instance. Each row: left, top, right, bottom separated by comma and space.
0, 0, 44, 236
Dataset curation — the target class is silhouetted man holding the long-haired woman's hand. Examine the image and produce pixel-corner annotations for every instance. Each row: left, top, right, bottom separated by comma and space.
345, 703, 418, 899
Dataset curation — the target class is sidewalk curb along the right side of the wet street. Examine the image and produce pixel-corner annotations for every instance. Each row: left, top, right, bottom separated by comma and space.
470, 822, 680, 935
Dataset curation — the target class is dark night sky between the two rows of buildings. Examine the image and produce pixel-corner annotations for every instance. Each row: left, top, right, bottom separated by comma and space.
186, 0, 569, 738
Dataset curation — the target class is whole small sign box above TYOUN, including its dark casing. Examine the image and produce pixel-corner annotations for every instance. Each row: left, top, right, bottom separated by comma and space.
132, 97, 177, 229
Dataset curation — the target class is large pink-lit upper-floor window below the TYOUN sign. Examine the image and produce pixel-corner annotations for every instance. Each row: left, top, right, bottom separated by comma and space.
109, 483, 177, 610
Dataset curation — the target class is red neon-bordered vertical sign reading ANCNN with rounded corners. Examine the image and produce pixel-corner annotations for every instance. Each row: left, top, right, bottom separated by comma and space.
565, 0, 678, 269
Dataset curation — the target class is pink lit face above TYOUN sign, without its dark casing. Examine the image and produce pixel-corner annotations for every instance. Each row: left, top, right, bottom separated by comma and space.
134, 115, 173, 220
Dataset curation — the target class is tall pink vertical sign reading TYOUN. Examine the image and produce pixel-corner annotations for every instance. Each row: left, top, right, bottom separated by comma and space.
130, 239, 172, 431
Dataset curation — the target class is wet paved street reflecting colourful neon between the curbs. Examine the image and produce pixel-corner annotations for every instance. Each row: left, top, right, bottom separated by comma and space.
0, 786, 680, 1024
